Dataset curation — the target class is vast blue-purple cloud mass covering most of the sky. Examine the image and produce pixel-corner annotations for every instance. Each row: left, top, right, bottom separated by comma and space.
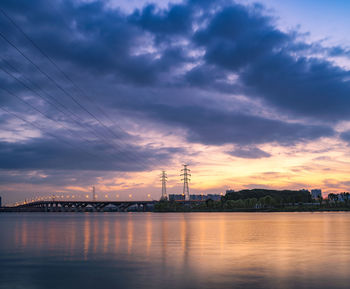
0, 0, 350, 200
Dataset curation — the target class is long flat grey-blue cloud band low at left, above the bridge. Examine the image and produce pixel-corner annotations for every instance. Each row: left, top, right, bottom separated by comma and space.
0, 138, 180, 171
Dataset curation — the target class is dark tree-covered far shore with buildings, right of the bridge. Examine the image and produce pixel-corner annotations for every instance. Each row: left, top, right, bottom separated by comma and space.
155, 189, 350, 212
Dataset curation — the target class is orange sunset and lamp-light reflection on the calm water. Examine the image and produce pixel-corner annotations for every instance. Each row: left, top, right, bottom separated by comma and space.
6, 209, 350, 288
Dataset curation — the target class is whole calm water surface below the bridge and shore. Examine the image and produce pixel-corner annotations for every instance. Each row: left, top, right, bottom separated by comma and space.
0, 213, 350, 289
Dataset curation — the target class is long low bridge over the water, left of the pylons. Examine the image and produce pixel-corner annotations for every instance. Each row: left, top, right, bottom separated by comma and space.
6, 201, 158, 212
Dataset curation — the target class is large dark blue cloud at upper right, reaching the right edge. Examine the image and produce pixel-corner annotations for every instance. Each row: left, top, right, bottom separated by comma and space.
194, 1, 350, 121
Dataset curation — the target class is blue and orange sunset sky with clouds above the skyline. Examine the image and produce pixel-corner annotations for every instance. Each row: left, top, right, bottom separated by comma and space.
0, 0, 350, 204
